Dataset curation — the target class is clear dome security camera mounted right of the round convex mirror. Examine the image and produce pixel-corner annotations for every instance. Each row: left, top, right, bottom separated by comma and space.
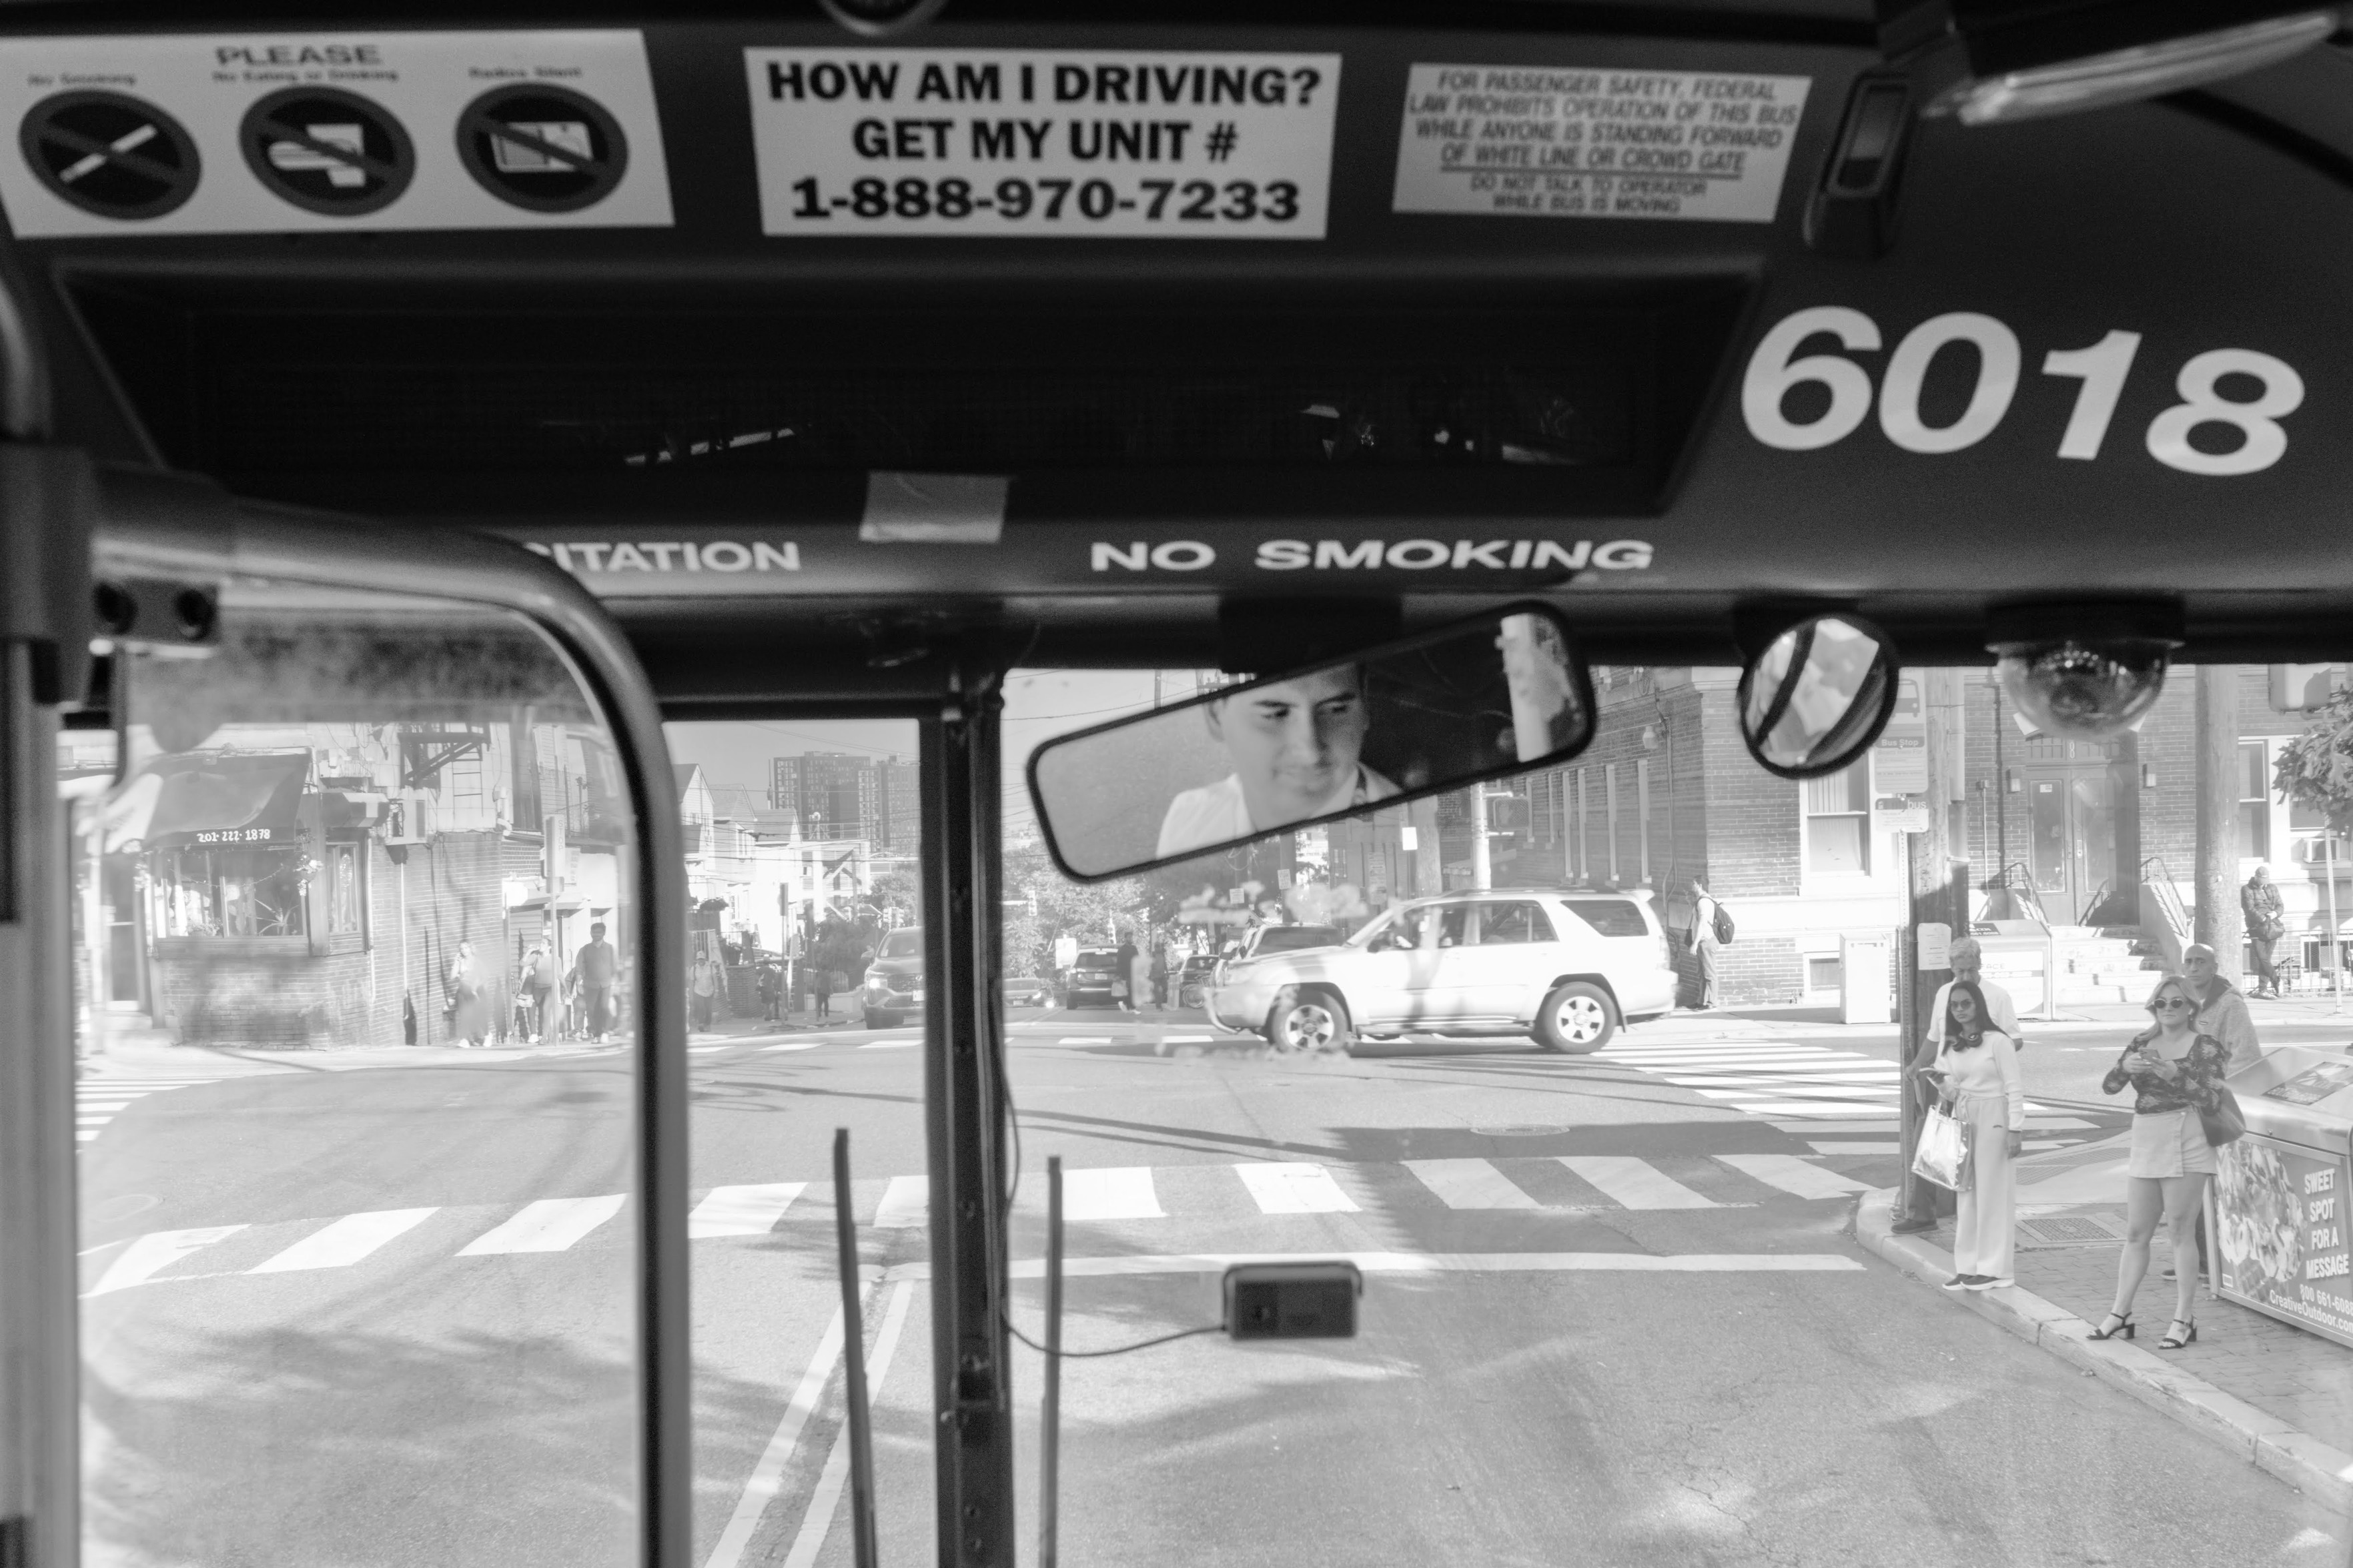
1986, 606, 2182, 740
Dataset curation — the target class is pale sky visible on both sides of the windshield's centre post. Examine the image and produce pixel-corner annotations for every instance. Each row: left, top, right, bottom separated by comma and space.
666, 670, 1198, 832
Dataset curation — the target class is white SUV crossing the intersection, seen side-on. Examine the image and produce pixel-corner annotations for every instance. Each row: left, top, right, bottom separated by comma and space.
1205, 888, 1675, 1056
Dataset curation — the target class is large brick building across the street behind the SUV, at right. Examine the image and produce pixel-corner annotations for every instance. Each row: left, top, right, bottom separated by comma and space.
1440, 668, 2353, 1004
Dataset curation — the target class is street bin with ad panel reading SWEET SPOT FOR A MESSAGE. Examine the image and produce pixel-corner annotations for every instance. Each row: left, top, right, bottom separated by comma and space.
2214, 1046, 2353, 1345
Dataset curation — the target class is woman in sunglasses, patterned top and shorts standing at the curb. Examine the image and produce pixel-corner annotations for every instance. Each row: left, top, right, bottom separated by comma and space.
2092, 976, 2231, 1349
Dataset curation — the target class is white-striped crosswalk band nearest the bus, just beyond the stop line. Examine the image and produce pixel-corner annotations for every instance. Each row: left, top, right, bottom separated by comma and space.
85, 1154, 1871, 1298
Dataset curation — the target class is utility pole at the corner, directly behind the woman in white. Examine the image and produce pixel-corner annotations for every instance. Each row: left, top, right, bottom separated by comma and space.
1880, 670, 1969, 1232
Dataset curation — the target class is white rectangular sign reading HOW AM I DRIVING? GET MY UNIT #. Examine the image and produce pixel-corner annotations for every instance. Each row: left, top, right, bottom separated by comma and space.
744, 49, 1339, 240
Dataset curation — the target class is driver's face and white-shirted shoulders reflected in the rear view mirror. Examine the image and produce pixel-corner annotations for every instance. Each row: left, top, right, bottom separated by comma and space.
1157, 666, 1398, 856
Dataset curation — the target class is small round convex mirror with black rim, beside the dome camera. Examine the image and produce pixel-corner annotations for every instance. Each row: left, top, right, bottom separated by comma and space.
1739, 616, 1897, 778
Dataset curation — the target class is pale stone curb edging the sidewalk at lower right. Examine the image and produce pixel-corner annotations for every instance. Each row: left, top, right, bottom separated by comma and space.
1854, 1187, 2353, 1511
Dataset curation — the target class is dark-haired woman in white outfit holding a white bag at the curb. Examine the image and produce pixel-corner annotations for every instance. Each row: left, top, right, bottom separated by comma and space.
1932, 980, 2026, 1291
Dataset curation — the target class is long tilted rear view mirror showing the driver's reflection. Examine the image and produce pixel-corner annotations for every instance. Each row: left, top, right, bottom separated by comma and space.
1028, 604, 1593, 879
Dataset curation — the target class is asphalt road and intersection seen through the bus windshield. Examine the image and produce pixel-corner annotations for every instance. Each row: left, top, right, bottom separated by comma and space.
82, 1011, 2348, 1568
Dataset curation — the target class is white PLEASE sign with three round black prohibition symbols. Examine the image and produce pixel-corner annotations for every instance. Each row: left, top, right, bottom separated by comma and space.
0, 28, 670, 240
